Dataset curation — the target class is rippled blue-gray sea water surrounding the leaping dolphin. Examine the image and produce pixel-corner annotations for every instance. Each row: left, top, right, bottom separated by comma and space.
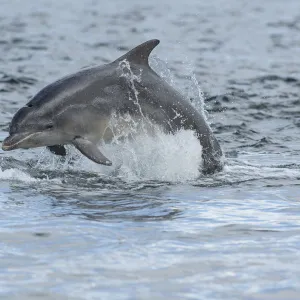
0, 0, 300, 300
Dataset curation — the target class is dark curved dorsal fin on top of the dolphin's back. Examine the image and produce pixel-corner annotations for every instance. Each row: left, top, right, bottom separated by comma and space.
116, 40, 159, 66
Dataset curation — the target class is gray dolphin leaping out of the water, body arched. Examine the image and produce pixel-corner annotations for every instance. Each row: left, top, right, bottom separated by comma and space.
2, 40, 223, 174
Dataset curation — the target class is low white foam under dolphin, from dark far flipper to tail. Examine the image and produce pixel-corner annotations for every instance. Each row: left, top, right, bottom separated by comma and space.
36, 128, 202, 182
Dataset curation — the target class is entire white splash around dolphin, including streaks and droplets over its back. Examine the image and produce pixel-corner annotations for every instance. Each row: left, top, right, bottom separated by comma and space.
25, 60, 203, 182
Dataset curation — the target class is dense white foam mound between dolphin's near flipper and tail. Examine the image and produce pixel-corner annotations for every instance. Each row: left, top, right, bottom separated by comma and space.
103, 129, 201, 181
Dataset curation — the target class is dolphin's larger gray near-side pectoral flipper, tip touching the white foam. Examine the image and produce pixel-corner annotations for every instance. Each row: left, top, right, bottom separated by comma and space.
73, 137, 112, 166
